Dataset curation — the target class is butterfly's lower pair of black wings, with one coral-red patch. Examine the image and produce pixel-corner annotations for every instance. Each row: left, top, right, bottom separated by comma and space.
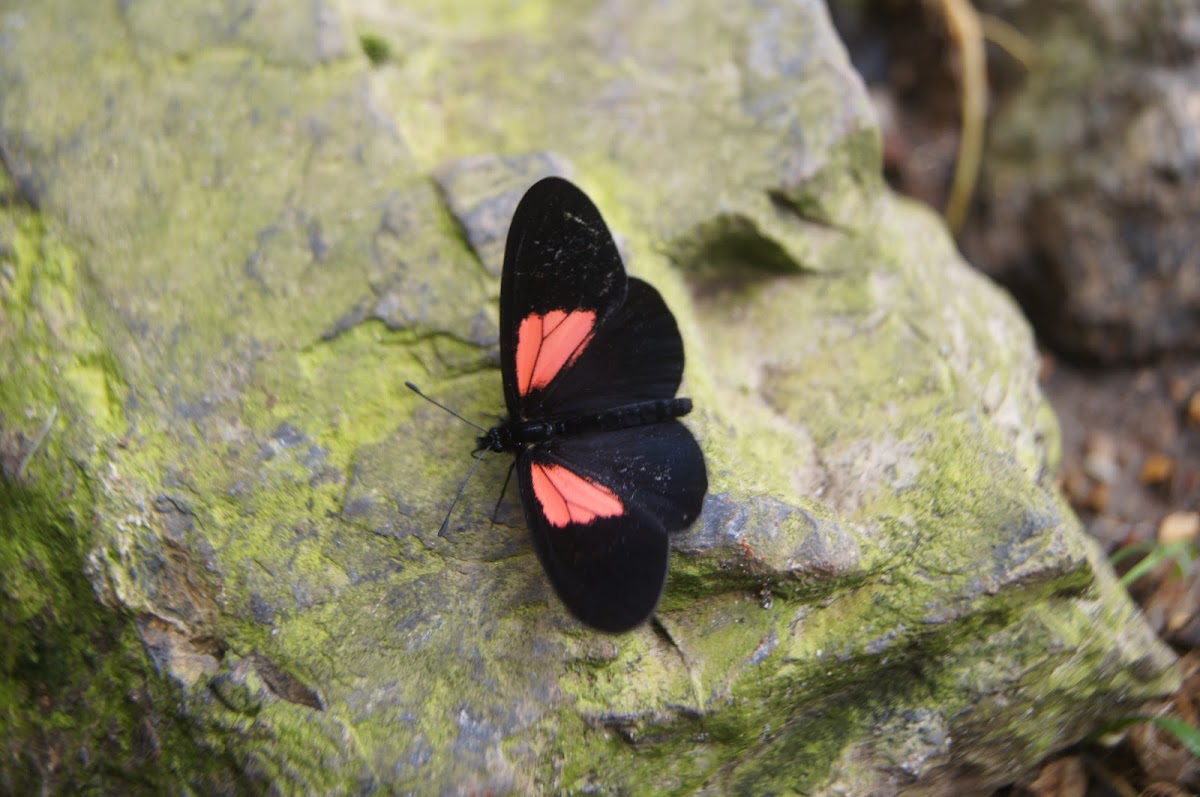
517, 420, 708, 631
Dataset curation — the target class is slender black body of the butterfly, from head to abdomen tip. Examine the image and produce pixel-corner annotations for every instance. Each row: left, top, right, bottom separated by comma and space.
476, 399, 691, 453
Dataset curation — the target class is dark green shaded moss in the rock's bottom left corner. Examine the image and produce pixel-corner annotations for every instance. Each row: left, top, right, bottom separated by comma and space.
0, 474, 184, 793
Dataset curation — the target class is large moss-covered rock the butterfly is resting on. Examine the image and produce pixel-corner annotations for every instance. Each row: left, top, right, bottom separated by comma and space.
0, 0, 1175, 793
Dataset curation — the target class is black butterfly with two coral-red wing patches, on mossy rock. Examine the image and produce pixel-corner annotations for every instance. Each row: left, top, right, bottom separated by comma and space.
409, 176, 708, 633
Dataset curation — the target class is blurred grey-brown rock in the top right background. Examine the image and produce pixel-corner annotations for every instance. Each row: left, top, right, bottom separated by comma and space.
965, 0, 1200, 362
